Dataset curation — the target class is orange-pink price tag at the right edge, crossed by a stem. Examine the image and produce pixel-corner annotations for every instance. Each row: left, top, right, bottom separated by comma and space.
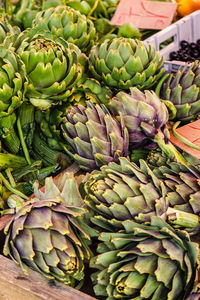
170, 120, 200, 159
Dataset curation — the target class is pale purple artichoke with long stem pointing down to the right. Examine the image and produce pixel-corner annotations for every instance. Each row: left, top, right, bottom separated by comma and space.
108, 87, 186, 163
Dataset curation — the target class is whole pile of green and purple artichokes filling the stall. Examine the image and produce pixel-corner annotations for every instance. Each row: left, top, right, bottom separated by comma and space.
0, 0, 200, 300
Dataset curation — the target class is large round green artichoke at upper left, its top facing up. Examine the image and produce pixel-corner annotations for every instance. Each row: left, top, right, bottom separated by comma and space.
14, 31, 87, 109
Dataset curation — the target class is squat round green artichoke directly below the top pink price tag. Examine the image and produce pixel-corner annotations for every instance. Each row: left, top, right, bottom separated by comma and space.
89, 37, 164, 90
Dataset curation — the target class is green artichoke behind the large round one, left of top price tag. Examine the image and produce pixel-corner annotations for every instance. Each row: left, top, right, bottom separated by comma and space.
33, 6, 96, 52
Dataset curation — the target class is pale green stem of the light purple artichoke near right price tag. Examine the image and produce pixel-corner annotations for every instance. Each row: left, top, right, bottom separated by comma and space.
154, 131, 188, 165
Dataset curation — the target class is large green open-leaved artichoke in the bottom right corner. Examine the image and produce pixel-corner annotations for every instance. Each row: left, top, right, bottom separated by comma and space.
91, 217, 199, 300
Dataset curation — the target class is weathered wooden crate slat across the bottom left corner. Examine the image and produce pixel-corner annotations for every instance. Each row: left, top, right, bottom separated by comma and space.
0, 255, 97, 300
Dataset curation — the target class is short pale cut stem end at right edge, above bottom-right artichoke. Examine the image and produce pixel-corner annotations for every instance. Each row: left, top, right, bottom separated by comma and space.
167, 207, 199, 228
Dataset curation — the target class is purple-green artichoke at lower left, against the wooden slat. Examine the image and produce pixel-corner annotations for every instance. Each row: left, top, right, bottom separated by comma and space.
4, 173, 90, 286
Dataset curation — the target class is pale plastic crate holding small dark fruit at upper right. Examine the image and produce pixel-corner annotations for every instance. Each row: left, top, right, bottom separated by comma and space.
145, 10, 200, 60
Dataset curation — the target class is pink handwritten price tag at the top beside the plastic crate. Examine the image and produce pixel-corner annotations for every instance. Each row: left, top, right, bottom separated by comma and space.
111, 0, 177, 30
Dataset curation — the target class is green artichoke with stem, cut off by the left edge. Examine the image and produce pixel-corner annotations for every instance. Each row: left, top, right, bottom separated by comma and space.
0, 46, 28, 154
